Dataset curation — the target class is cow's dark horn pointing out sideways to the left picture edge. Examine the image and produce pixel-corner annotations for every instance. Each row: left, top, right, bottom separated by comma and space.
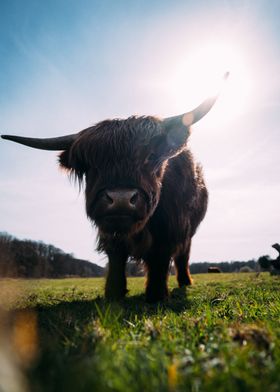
1, 133, 79, 151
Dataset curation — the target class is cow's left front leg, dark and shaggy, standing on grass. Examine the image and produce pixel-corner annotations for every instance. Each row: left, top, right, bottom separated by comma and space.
105, 253, 127, 300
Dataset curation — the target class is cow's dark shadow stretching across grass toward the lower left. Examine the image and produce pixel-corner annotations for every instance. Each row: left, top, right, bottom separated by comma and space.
22, 289, 191, 392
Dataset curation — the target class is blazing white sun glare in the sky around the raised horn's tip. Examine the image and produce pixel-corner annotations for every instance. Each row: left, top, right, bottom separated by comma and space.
167, 44, 253, 121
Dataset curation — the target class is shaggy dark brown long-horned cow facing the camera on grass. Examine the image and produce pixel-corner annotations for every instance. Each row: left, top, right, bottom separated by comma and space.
2, 76, 228, 302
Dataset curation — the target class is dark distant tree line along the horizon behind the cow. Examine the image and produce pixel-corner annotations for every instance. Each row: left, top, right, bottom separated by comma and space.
0, 232, 280, 278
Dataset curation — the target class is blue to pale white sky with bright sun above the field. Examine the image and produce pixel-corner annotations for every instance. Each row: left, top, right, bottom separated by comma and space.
0, 0, 280, 263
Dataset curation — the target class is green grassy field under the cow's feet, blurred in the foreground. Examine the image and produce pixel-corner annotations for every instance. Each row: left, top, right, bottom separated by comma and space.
0, 273, 280, 392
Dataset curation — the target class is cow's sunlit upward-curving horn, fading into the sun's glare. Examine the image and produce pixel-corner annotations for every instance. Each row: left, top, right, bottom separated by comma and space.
163, 72, 229, 128
